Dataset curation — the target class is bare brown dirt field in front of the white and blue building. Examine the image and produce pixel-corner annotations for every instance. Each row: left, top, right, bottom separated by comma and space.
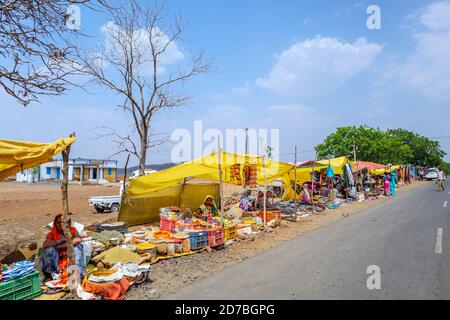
0, 182, 119, 257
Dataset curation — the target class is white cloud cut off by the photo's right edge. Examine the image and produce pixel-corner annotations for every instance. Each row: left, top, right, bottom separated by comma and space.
380, 1, 450, 101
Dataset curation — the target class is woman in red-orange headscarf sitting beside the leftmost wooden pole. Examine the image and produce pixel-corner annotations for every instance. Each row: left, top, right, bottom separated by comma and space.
40, 214, 86, 279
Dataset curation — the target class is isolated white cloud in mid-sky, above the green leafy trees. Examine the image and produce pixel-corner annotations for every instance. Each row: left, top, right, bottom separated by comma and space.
256, 36, 382, 97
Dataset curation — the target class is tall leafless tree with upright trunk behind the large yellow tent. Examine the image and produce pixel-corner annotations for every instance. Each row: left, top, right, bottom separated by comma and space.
80, 0, 210, 175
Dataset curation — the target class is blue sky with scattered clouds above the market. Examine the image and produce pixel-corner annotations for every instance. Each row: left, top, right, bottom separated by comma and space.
0, 0, 450, 165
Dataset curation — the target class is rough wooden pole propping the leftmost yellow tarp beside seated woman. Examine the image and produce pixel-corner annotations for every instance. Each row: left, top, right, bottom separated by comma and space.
61, 133, 76, 265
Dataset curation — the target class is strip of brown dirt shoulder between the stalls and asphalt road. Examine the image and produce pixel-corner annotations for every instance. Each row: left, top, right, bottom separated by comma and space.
126, 182, 426, 300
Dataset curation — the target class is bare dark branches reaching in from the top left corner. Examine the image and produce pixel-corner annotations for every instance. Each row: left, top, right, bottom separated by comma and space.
0, 0, 108, 106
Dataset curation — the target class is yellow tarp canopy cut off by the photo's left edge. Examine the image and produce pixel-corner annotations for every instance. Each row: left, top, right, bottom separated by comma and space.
0, 137, 76, 181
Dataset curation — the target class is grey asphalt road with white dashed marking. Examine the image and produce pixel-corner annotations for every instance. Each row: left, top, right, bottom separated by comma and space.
168, 181, 450, 300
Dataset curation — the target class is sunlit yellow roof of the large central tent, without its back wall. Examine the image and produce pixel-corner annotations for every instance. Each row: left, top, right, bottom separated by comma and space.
126, 152, 294, 196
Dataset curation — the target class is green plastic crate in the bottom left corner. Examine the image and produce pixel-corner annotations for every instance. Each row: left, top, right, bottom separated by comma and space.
0, 271, 41, 300
